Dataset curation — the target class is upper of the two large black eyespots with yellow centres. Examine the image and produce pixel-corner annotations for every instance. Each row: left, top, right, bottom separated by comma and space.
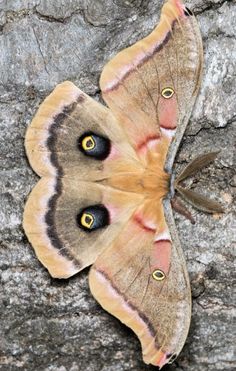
78, 131, 111, 160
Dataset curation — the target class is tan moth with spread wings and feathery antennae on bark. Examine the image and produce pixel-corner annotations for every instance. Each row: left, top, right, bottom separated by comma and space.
23, 0, 221, 368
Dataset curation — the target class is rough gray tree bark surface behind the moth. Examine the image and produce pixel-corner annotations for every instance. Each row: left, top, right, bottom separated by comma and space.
0, 0, 236, 371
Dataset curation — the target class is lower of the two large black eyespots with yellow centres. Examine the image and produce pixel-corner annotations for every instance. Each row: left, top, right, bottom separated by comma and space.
76, 205, 110, 232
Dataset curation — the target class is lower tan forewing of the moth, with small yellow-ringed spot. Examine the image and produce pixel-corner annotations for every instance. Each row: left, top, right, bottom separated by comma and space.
90, 201, 191, 367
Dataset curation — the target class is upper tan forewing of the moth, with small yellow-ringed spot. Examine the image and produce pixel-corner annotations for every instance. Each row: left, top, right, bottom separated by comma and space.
100, 0, 202, 170
